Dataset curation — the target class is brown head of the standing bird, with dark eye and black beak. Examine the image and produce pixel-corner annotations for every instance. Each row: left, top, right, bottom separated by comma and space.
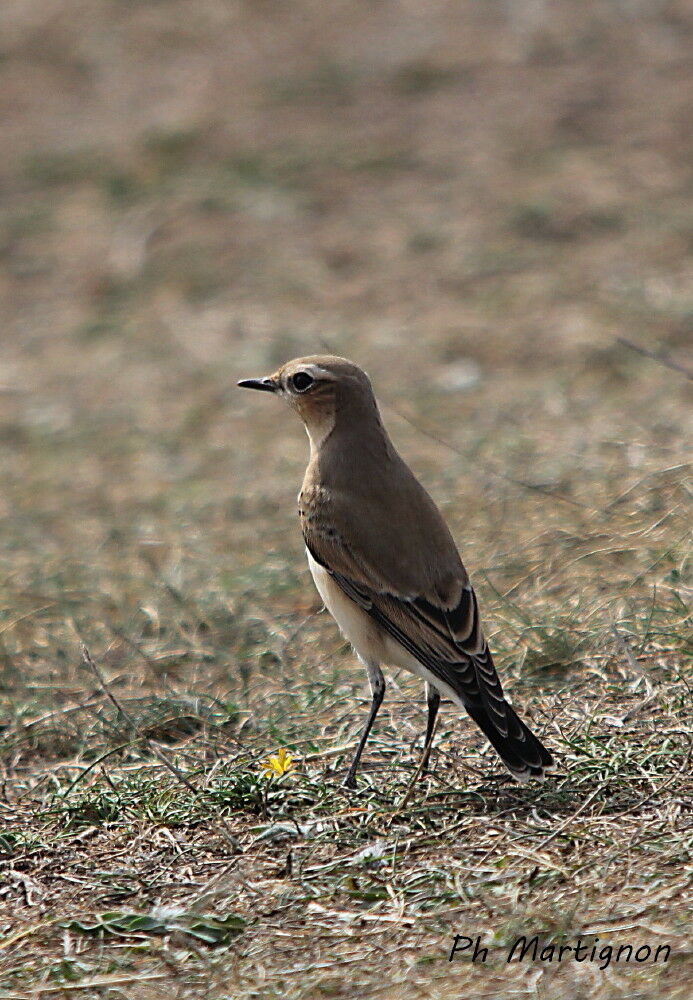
238, 354, 377, 448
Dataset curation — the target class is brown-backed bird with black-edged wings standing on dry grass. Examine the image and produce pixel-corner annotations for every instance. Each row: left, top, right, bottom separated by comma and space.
238, 354, 554, 788
